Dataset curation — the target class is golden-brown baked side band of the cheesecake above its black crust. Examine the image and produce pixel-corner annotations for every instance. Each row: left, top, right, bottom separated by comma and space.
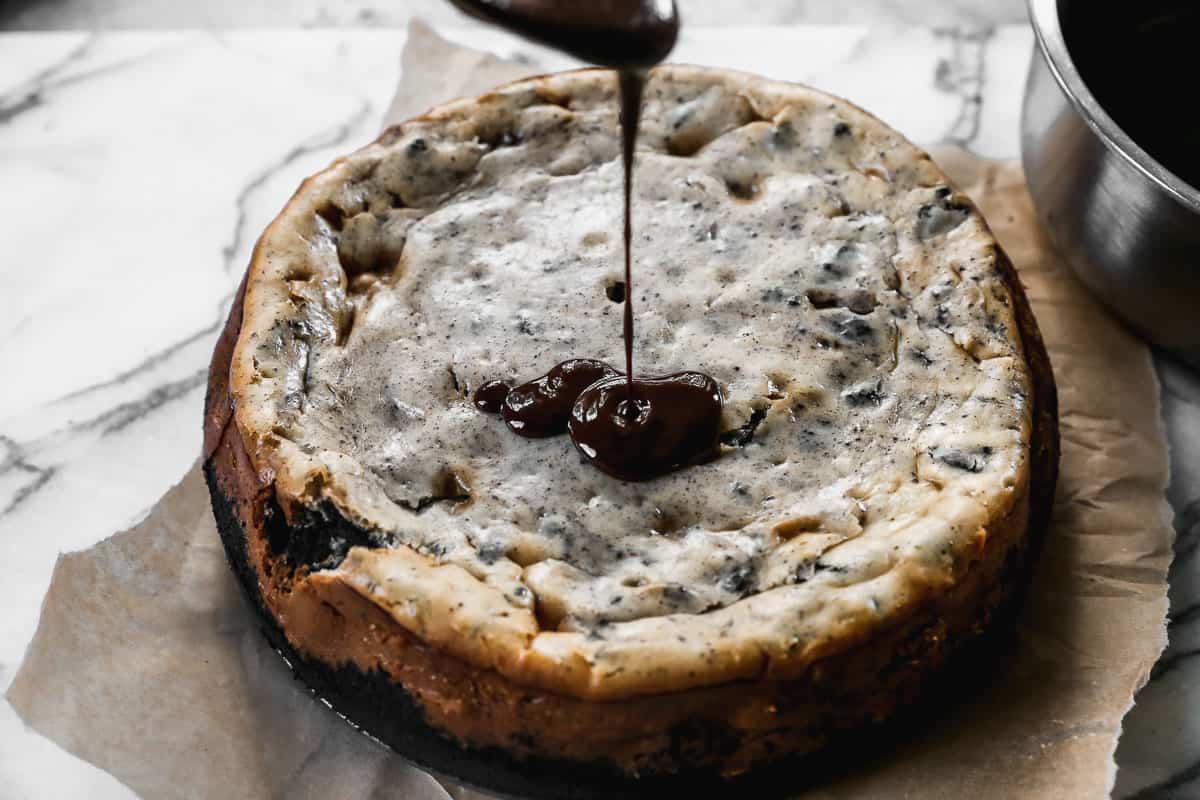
205, 244, 1058, 776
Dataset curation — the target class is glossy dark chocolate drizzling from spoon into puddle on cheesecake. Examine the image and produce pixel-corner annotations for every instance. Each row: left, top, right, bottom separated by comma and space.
452, 0, 721, 481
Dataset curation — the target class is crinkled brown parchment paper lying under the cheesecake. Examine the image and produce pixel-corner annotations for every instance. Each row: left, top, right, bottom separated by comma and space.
8, 25, 1171, 800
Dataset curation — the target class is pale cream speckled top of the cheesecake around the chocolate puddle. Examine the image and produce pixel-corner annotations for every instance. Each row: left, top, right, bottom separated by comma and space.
234, 67, 1030, 695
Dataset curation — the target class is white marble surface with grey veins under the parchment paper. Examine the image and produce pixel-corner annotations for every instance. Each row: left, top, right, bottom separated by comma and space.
0, 25, 1200, 799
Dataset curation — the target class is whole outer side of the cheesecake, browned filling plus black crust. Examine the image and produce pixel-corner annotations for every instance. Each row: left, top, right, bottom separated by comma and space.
205, 232, 1058, 796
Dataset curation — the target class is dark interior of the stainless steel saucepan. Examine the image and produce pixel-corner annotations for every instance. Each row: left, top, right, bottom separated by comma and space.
1060, 0, 1200, 187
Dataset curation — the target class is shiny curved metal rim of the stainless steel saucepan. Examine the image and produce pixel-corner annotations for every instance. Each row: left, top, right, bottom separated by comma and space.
1028, 0, 1200, 213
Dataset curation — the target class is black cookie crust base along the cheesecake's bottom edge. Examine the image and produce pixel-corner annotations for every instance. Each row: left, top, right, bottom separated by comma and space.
204, 470, 1044, 800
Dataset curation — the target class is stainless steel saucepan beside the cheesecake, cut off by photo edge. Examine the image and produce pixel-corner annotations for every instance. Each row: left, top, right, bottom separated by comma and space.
1021, 0, 1200, 367
